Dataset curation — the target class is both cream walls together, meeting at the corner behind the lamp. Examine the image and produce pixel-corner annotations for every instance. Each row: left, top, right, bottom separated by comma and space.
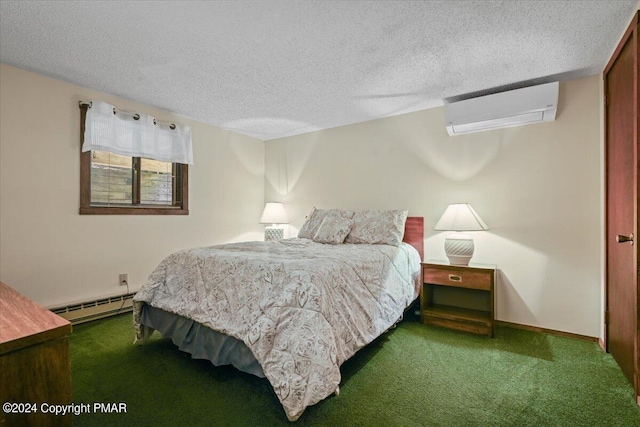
0, 65, 603, 336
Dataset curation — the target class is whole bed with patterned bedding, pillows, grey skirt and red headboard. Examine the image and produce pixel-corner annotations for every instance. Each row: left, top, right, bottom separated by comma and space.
133, 208, 423, 421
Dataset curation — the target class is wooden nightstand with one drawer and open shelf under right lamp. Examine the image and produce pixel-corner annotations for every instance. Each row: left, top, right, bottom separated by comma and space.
420, 261, 497, 337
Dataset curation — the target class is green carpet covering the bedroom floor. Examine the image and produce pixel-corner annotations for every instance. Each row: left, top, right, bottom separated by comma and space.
71, 314, 640, 427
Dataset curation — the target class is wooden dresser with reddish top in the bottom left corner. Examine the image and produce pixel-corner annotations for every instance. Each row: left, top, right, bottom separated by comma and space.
0, 282, 73, 427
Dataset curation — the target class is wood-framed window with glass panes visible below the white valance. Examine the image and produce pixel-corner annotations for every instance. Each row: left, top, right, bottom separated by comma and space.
80, 102, 189, 215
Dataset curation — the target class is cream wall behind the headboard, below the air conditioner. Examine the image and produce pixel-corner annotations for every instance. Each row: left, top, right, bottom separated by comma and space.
265, 76, 603, 337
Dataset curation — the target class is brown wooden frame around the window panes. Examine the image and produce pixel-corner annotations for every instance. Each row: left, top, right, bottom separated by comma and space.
80, 105, 189, 215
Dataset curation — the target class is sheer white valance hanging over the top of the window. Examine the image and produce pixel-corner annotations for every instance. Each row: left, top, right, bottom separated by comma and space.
82, 101, 193, 165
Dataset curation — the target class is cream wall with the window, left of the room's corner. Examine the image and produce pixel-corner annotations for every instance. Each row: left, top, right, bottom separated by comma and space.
0, 64, 264, 307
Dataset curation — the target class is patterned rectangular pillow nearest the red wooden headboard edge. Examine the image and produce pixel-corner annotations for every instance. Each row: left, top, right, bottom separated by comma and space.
345, 210, 409, 246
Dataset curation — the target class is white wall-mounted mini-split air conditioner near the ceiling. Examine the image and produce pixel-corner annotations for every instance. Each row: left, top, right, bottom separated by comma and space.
444, 82, 559, 135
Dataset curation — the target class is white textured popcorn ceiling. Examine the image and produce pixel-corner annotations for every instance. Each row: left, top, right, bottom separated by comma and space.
0, 0, 638, 140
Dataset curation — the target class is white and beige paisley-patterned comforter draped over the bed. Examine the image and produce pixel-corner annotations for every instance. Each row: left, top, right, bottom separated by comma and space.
134, 238, 420, 421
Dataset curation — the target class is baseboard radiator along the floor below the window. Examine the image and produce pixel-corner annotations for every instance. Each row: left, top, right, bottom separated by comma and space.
51, 293, 135, 325
